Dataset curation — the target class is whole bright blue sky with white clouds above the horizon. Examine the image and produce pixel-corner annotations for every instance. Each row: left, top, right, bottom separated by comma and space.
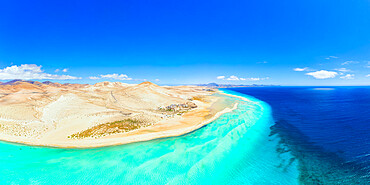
0, 0, 370, 85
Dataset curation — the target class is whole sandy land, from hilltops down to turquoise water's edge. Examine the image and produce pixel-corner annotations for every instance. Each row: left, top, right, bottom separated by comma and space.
0, 82, 240, 148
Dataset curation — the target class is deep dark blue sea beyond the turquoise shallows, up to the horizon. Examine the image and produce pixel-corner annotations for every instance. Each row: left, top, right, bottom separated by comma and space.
230, 87, 370, 184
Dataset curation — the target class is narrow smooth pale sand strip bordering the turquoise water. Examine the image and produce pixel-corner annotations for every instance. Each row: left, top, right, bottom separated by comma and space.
0, 91, 249, 148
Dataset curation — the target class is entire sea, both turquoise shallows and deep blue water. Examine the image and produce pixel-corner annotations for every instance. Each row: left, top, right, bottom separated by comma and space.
0, 87, 370, 185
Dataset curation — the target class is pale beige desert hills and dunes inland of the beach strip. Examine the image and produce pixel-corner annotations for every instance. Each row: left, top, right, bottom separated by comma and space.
0, 80, 218, 147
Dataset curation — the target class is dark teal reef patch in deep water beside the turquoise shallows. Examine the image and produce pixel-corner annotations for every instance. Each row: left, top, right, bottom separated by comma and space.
270, 120, 370, 184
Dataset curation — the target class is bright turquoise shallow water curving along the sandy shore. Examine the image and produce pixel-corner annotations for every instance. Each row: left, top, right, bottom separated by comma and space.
0, 92, 299, 184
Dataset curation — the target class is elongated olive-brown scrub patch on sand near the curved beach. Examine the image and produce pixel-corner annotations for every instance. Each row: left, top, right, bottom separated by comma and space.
68, 118, 150, 139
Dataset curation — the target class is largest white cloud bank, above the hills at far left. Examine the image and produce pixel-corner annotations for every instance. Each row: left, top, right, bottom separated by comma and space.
0, 64, 81, 80
